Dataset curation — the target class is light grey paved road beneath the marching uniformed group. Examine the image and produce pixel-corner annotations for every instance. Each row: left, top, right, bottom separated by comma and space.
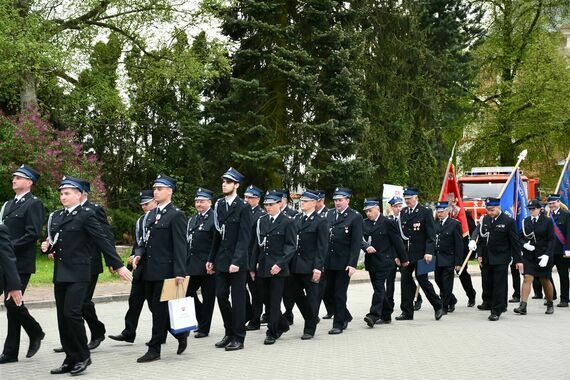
0, 277, 570, 380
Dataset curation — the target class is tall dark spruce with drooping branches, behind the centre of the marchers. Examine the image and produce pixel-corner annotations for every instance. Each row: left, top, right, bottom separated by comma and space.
202, 0, 365, 193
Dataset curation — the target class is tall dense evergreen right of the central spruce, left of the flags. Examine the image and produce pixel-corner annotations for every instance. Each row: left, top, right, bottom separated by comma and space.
352, 0, 481, 195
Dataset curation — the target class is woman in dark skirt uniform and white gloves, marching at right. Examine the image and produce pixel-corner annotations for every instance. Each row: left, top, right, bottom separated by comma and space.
514, 199, 554, 315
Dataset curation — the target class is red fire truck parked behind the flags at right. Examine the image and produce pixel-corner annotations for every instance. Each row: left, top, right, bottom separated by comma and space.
457, 166, 540, 222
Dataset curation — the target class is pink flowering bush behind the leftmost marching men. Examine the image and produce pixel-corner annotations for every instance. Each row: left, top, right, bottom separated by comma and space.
0, 112, 105, 211
